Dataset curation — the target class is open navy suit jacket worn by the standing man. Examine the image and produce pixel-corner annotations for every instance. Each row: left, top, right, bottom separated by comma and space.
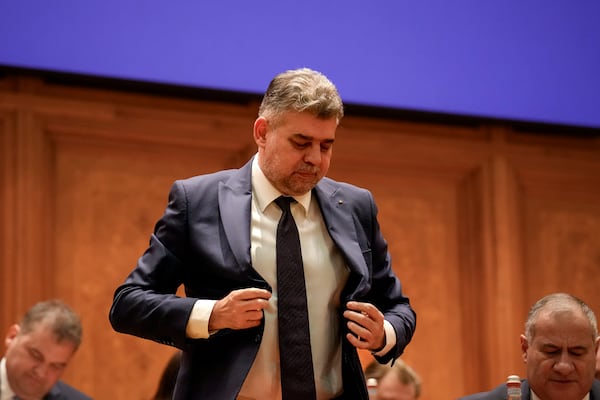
110, 161, 416, 400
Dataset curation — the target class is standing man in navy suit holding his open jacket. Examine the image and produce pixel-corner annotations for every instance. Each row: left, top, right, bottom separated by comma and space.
110, 68, 416, 400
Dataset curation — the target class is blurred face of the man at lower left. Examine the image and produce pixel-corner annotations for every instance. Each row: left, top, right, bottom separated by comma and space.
5, 323, 76, 399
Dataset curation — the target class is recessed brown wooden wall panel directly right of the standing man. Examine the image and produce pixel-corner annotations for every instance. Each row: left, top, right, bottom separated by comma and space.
330, 119, 489, 399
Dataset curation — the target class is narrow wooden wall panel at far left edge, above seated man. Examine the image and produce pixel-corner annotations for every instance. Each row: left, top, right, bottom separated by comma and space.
0, 107, 52, 326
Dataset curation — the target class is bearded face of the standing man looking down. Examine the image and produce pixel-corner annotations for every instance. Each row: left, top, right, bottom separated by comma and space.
254, 112, 337, 196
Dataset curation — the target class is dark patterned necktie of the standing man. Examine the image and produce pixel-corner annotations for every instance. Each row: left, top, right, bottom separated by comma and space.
275, 196, 316, 400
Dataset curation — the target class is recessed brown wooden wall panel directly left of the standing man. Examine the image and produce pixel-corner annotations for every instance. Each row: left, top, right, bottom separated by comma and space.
48, 102, 251, 399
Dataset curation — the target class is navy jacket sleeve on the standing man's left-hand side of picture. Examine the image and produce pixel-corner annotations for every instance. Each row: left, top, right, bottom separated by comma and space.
109, 182, 195, 348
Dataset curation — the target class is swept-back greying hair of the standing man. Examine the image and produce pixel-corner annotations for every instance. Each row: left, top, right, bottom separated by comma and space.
258, 68, 344, 124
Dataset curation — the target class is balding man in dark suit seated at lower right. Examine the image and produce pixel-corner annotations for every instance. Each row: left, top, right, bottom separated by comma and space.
459, 293, 600, 400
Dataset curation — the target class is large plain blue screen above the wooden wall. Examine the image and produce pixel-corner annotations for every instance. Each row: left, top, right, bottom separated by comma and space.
0, 0, 600, 128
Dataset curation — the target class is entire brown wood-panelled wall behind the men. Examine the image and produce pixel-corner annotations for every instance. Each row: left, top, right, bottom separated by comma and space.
0, 76, 600, 400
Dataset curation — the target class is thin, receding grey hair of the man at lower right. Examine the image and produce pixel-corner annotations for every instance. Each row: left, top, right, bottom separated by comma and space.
525, 293, 598, 341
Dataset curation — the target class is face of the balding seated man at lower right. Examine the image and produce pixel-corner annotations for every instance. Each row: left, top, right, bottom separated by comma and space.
521, 310, 598, 400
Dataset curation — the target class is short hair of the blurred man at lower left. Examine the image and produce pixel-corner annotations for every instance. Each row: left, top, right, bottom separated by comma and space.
19, 299, 83, 349
